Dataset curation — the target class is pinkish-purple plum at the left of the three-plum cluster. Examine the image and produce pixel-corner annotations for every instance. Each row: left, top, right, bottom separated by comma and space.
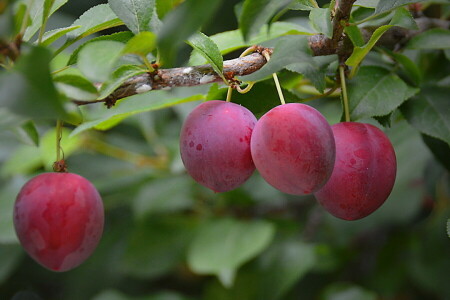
180, 100, 256, 192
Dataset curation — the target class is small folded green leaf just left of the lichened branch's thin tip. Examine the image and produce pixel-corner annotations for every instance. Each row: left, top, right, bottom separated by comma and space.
53, 74, 98, 100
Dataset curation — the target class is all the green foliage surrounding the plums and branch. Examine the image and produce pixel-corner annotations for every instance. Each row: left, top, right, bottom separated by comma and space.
0, 0, 450, 300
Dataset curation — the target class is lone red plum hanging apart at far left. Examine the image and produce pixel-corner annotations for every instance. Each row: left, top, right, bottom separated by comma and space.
13, 173, 104, 272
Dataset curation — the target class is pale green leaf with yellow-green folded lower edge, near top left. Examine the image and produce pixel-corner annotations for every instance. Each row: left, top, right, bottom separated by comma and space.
67, 4, 123, 43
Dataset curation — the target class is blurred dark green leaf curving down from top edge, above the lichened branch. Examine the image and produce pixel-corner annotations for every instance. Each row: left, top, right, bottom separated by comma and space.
158, 0, 222, 68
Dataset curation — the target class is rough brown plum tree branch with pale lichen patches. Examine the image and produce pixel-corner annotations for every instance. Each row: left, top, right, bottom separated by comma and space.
72, 13, 450, 107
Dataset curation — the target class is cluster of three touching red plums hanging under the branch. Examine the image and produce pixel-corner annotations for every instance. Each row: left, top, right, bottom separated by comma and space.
180, 100, 396, 220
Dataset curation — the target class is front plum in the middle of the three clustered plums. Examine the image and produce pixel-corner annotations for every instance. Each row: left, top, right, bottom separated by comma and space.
251, 103, 335, 195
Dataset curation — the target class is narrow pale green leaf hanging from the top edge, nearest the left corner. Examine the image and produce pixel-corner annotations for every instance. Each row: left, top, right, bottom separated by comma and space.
23, 0, 68, 41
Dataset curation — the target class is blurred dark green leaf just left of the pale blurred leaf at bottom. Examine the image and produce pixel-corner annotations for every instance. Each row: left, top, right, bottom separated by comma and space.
121, 216, 198, 278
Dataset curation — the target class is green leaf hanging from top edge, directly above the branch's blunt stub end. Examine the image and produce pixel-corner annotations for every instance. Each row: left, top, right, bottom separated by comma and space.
239, 0, 289, 41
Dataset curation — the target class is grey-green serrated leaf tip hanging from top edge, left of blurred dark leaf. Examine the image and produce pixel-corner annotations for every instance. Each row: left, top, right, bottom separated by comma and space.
108, 0, 155, 34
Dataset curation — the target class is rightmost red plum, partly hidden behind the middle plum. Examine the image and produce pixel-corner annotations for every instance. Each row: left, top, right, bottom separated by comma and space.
315, 122, 397, 220
